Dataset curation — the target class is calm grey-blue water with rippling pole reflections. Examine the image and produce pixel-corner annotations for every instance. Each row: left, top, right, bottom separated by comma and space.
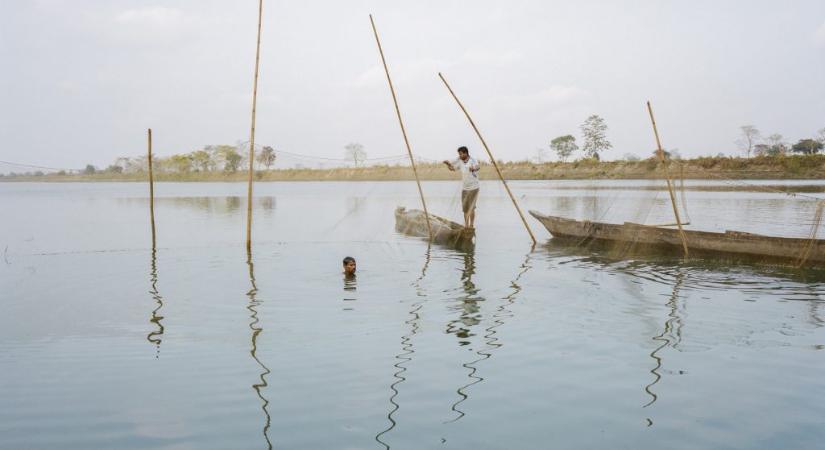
0, 181, 825, 449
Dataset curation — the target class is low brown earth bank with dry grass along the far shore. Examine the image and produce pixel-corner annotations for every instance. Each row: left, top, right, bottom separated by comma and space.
0, 154, 825, 182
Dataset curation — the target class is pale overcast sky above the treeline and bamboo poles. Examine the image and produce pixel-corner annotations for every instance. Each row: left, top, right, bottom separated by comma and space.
0, 0, 825, 171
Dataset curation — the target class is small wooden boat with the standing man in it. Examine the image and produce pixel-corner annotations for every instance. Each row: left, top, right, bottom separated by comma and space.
395, 206, 475, 248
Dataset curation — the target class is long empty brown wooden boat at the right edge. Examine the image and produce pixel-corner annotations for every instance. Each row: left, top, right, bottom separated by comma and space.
530, 211, 825, 266
